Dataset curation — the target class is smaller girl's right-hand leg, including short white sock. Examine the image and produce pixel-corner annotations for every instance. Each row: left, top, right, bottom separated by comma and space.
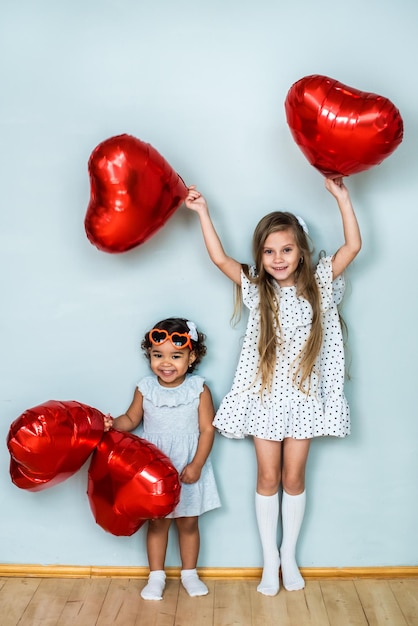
176, 517, 209, 596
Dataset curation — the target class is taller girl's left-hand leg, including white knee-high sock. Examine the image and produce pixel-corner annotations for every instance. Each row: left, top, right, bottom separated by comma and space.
254, 437, 282, 596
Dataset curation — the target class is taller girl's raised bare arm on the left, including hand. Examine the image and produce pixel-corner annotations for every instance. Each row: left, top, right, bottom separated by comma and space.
184, 185, 241, 285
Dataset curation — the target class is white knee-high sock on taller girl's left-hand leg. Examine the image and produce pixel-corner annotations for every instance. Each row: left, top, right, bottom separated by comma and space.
255, 493, 280, 596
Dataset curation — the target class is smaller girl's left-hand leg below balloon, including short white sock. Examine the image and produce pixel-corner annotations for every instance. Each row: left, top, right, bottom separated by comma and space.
141, 518, 171, 600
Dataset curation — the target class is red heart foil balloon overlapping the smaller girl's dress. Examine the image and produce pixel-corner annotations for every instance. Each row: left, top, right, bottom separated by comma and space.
87, 429, 180, 536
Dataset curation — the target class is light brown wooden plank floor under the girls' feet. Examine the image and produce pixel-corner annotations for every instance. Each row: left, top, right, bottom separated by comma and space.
0, 577, 418, 626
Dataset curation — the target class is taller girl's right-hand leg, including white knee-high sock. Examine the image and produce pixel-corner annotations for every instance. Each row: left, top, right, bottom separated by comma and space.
280, 439, 310, 591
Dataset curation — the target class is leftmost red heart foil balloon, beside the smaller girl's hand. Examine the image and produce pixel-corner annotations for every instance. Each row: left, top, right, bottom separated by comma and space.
7, 400, 104, 491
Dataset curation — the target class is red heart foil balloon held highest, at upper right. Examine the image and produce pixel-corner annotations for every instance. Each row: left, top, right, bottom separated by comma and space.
285, 75, 403, 178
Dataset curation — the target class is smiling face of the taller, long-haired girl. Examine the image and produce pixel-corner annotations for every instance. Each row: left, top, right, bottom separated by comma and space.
262, 229, 302, 287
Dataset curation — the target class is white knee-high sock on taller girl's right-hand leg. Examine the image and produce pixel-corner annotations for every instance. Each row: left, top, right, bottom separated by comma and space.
280, 490, 306, 591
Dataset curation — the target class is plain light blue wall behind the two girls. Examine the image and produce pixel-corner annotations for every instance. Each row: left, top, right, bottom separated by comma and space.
0, 0, 418, 567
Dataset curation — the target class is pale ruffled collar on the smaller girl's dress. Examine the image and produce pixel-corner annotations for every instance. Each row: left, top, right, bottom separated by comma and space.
137, 374, 205, 407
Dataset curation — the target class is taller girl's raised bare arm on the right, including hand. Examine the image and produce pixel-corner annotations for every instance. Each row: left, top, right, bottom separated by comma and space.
325, 178, 361, 278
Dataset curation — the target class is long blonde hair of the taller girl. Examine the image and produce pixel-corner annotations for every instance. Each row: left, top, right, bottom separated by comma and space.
238, 211, 322, 393
